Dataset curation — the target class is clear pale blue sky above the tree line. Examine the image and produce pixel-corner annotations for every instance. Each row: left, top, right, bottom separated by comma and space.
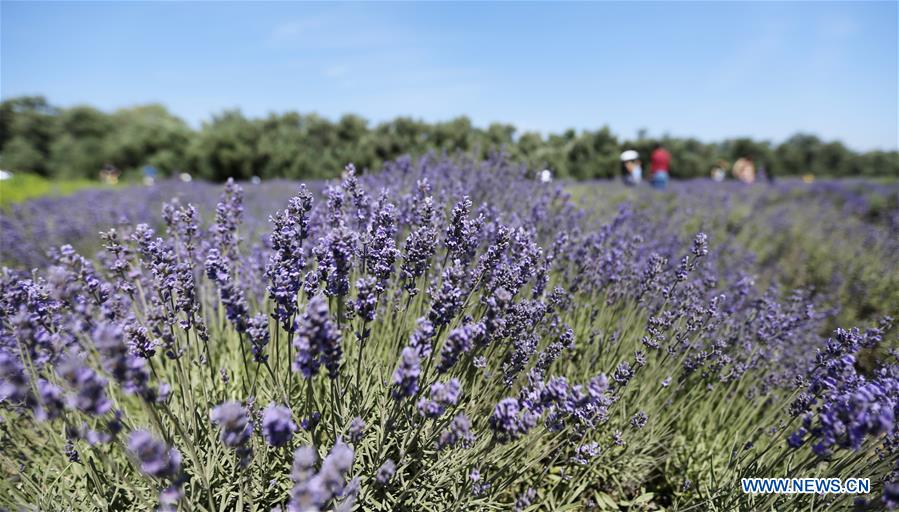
0, 1, 899, 149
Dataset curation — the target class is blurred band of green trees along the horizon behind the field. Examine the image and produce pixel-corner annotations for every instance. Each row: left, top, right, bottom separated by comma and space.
0, 96, 899, 181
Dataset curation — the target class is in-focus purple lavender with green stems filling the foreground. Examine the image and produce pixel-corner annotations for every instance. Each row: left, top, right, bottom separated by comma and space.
0, 157, 899, 511
